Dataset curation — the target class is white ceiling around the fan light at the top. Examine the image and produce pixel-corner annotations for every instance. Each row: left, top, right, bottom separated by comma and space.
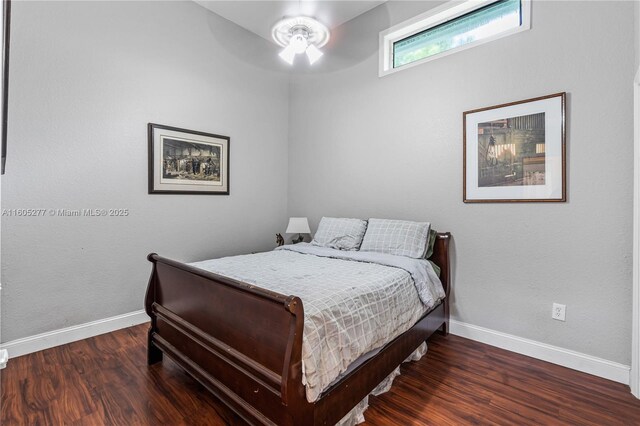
194, 0, 386, 41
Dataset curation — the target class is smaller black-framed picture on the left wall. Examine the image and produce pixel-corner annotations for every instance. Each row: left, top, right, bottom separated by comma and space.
148, 123, 230, 195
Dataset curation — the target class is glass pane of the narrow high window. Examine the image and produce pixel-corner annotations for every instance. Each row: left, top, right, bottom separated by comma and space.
393, 0, 522, 68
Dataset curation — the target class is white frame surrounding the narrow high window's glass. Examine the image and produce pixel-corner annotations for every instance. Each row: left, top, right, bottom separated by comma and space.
378, 0, 531, 77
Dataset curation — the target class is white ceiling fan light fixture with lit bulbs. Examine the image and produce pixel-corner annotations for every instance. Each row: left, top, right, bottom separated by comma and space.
271, 16, 329, 65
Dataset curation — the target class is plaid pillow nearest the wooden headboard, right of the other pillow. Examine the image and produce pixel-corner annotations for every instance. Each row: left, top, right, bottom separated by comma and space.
360, 219, 431, 259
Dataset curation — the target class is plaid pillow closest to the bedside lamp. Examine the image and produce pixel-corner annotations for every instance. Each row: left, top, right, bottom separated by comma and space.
311, 217, 367, 250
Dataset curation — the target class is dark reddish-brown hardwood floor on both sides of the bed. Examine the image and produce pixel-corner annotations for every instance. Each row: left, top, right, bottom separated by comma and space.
0, 324, 640, 425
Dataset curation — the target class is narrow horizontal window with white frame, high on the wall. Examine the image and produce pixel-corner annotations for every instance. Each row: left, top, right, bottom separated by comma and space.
380, 0, 531, 76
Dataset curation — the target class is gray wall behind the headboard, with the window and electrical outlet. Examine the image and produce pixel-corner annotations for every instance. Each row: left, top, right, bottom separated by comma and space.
289, 1, 635, 364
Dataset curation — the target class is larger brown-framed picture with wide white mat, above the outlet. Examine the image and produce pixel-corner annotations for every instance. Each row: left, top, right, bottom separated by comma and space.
463, 92, 567, 203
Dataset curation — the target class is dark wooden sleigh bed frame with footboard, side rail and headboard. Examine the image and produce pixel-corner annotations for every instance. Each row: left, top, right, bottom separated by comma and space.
145, 233, 451, 425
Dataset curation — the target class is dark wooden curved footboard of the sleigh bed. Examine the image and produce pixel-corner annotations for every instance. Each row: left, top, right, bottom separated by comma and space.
145, 254, 304, 425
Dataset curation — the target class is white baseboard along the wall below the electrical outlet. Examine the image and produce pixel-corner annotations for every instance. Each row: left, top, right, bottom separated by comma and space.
449, 320, 630, 385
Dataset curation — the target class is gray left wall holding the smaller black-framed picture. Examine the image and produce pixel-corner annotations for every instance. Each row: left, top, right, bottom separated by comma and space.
2, 2, 288, 342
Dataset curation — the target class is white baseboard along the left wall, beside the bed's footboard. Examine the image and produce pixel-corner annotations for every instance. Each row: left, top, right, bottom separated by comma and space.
0, 310, 149, 359
